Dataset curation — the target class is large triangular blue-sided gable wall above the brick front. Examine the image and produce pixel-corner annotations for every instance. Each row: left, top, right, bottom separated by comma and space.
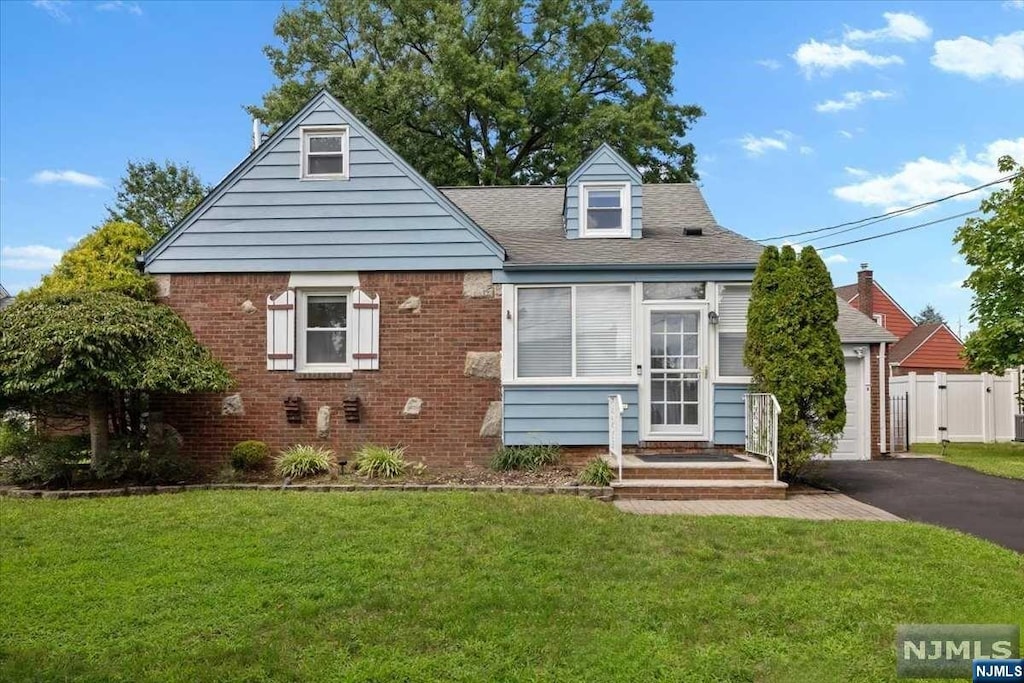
146, 93, 502, 272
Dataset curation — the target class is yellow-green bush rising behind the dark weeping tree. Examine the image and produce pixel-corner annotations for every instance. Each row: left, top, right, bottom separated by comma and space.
41, 222, 155, 301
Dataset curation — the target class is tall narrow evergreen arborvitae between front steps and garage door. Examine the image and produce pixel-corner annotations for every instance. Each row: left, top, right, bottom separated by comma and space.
743, 246, 846, 476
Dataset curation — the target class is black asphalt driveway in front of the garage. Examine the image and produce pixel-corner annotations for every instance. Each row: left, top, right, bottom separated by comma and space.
819, 458, 1024, 553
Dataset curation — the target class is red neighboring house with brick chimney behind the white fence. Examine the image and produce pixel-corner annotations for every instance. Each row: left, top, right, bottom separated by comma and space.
836, 263, 968, 376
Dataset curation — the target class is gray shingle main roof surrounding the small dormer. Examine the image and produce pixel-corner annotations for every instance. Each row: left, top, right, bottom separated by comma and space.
441, 183, 762, 267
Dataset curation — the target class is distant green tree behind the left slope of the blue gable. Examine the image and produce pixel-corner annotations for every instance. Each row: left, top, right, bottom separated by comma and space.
106, 161, 210, 241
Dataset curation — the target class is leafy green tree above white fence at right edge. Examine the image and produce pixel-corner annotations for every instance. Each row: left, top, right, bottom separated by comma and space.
953, 156, 1024, 373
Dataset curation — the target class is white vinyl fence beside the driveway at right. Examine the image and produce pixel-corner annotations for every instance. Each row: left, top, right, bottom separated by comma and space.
889, 370, 1021, 443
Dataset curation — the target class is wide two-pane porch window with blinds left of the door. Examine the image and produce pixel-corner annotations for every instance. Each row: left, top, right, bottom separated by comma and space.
516, 285, 635, 380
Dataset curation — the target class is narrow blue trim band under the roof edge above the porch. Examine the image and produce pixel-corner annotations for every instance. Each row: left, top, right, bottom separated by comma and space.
492, 263, 757, 285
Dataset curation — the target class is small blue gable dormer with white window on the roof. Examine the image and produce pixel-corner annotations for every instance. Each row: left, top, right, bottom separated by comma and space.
564, 142, 643, 240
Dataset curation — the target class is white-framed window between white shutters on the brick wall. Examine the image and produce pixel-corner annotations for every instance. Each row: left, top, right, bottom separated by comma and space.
298, 291, 351, 372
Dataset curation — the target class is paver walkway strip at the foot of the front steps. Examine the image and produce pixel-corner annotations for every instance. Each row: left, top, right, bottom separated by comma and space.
615, 494, 902, 521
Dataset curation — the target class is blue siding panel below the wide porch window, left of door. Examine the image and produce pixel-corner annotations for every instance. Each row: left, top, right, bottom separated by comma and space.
503, 384, 639, 445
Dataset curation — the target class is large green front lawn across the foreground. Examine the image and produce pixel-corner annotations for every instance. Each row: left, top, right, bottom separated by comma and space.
0, 492, 1024, 683
